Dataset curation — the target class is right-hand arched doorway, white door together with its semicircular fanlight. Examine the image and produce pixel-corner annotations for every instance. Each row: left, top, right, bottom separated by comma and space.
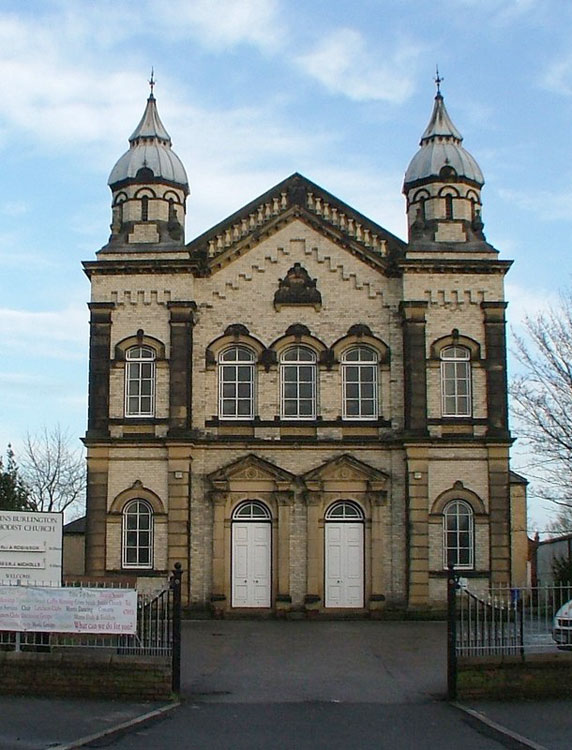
324, 500, 365, 608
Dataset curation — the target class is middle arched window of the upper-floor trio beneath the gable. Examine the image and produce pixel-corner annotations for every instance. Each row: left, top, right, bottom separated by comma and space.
280, 346, 317, 419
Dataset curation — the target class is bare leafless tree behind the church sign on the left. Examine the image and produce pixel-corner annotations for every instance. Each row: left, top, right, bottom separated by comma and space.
21, 425, 86, 512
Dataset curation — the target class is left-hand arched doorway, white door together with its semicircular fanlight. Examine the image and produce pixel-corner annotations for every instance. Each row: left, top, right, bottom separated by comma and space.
231, 500, 272, 607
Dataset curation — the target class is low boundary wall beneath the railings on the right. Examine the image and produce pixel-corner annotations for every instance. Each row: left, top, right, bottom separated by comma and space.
457, 651, 572, 701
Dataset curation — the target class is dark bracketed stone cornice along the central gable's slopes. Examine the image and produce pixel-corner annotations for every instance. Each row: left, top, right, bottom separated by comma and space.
187, 173, 406, 273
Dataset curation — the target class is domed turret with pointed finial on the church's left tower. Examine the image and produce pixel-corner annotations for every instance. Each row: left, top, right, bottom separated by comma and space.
107, 74, 189, 250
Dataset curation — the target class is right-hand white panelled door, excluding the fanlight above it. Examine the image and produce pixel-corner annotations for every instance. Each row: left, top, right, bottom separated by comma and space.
326, 521, 364, 607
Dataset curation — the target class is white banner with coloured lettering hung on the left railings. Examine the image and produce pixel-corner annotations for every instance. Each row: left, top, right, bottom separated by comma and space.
0, 586, 137, 635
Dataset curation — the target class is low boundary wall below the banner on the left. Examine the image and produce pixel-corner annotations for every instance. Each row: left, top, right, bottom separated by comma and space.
0, 651, 172, 701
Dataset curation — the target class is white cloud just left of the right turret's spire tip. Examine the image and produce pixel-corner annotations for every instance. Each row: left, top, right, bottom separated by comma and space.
296, 28, 422, 104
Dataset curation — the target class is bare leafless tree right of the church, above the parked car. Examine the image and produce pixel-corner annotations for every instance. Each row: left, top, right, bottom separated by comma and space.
510, 291, 572, 507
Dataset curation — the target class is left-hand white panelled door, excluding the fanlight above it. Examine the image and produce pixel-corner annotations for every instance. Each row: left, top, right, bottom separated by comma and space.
232, 521, 271, 607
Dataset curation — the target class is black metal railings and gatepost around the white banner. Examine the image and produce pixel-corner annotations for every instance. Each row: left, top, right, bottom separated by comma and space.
0, 563, 182, 691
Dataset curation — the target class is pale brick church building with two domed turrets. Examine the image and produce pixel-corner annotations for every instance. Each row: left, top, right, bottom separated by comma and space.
84, 81, 526, 617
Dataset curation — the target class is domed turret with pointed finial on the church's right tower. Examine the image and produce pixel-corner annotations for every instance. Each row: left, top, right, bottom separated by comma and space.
403, 72, 485, 243
